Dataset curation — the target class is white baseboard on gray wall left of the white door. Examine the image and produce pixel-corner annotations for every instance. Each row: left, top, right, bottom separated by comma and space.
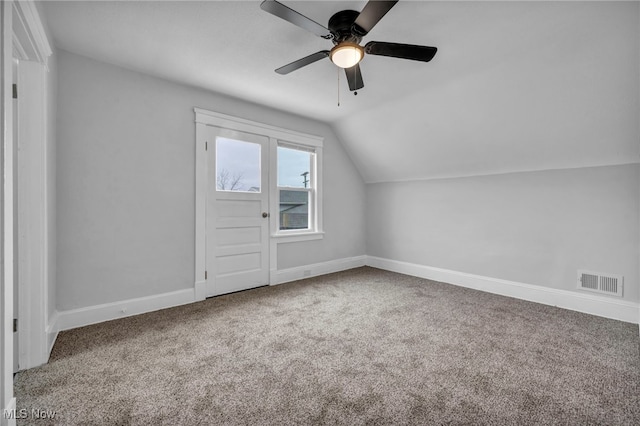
55, 288, 196, 331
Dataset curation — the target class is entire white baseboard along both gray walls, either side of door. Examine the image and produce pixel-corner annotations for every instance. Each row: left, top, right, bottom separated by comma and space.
31, 256, 640, 354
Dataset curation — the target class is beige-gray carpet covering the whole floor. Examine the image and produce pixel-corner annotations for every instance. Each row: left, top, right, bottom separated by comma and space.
15, 268, 640, 425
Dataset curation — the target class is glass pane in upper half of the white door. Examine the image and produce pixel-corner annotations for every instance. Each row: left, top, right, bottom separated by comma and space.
216, 138, 261, 192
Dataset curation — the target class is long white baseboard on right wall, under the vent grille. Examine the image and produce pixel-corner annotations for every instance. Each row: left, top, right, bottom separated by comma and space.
366, 256, 640, 324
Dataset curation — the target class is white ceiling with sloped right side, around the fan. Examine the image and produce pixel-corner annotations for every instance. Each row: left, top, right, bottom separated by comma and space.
43, 0, 640, 182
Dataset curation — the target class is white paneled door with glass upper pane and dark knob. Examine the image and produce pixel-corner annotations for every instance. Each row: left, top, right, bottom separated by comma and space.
206, 127, 269, 296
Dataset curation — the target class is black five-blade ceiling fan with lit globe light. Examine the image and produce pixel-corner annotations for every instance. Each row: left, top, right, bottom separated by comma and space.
260, 0, 438, 91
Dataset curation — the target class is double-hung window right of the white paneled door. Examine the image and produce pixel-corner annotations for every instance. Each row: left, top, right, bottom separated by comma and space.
277, 142, 320, 235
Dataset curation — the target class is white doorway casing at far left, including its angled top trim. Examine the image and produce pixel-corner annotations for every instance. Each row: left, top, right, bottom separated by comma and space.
12, 1, 53, 370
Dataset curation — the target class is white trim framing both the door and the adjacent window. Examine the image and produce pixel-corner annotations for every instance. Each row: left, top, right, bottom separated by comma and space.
194, 108, 324, 292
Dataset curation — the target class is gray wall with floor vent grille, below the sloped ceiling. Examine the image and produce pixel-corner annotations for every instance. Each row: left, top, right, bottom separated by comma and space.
367, 164, 640, 302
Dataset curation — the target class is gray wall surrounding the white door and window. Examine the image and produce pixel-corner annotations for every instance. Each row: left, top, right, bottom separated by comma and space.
56, 51, 365, 310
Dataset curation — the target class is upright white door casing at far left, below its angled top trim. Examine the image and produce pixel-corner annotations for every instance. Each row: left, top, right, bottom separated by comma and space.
16, 61, 51, 370
